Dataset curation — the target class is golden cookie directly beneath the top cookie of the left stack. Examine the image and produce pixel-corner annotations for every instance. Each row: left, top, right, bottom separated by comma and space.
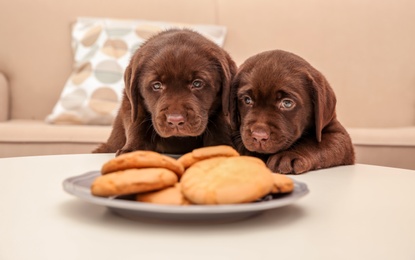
91, 168, 178, 197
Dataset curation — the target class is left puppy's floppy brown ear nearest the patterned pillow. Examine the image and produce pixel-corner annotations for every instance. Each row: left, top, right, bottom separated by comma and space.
124, 59, 144, 122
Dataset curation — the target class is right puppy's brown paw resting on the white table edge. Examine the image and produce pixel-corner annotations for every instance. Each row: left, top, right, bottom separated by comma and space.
267, 151, 312, 174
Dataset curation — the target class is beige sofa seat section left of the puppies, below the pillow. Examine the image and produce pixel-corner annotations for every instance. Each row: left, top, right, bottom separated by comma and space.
0, 120, 111, 158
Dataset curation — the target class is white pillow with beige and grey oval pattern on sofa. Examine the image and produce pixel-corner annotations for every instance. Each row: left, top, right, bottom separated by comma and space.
46, 17, 226, 125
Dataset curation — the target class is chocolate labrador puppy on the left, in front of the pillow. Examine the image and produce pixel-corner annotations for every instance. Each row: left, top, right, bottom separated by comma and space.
93, 29, 237, 155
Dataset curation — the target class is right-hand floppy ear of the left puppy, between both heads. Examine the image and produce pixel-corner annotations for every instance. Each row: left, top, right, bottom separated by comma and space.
219, 52, 237, 120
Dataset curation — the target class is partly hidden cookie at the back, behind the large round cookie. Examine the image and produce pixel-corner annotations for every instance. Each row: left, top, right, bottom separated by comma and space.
177, 145, 239, 169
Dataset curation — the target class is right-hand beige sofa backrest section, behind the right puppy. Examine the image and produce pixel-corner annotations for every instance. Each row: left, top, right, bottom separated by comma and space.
219, 0, 415, 127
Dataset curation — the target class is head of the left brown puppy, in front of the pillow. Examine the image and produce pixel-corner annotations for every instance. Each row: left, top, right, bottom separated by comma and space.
125, 30, 236, 138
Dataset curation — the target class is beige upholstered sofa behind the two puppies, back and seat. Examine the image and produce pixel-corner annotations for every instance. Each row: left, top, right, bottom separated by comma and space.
0, 0, 415, 169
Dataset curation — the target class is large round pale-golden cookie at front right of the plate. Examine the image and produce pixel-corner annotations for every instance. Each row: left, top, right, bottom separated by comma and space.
181, 156, 273, 204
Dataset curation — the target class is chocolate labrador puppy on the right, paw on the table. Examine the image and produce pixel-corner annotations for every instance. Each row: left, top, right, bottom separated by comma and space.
230, 50, 355, 174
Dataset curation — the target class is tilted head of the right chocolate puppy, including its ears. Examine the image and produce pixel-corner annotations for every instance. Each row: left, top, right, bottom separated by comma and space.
230, 50, 336, 154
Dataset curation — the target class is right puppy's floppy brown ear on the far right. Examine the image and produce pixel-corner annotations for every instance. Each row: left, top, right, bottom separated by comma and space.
307, 69, 336, 142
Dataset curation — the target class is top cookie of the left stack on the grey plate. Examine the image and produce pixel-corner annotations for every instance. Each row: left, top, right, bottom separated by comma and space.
101, 151, 184, 176
